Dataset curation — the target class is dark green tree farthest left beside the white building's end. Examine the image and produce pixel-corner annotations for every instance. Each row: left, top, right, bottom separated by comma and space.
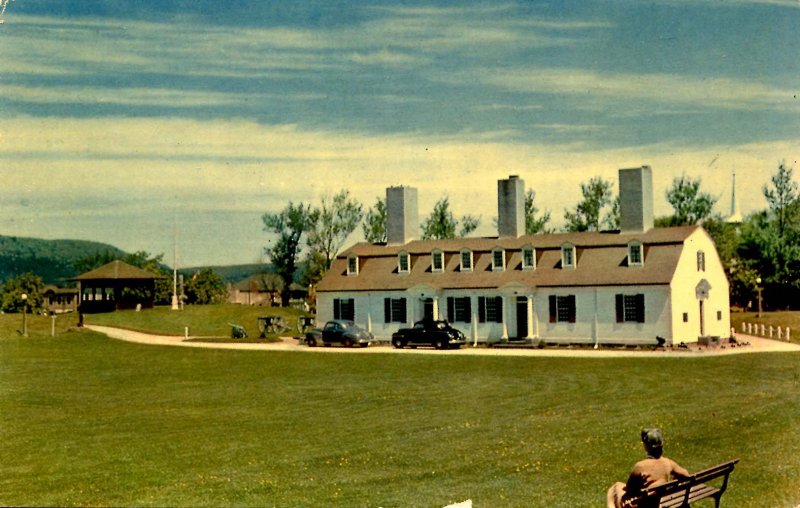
261, 201, 311, 303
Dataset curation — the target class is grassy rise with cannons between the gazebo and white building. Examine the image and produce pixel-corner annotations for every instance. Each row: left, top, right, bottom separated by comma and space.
83, 304, 301, 342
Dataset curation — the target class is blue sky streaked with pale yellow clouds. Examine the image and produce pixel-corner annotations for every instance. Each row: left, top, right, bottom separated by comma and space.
0, 0, 800, 267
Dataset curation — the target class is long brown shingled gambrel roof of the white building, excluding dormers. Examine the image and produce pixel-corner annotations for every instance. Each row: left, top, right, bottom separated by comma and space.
317, 226, 699, 292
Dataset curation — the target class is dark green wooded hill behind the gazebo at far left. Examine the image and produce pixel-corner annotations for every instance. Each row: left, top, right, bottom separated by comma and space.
0, 235, 126, 286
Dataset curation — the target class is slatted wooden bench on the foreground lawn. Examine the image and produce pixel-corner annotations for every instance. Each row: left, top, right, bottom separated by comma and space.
636, 459, 739, 508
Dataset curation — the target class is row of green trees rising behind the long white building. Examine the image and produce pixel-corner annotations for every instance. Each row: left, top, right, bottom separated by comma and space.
262, 163, 800, 309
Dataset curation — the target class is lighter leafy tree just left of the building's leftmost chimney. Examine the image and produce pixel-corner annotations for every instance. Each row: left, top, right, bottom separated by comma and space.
306, 189, 364, 284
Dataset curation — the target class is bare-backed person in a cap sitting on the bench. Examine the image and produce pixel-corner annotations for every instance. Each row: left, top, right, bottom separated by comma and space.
608, 429, 690, 508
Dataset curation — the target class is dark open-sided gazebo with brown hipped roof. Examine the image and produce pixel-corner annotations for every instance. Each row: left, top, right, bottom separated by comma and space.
70, 261, 161, 314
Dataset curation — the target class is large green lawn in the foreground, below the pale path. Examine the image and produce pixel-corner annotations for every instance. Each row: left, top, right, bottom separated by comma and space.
0, 315, 800, 508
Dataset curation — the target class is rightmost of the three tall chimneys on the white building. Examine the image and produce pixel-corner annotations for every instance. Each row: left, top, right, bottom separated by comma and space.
619, 166, 654, 233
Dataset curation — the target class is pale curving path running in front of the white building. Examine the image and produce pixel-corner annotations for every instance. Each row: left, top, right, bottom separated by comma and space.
86, 325, 800, 358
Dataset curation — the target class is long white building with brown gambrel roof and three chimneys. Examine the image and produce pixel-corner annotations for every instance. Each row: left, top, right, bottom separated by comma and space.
317, 166, 730, 344
